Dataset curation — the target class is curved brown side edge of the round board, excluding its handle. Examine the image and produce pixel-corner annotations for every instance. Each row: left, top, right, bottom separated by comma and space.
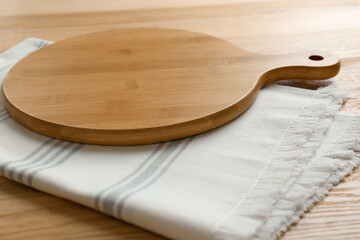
2, 81, 261, 146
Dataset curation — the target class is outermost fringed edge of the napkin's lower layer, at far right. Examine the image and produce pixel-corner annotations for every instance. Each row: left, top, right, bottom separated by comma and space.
255, 116, 360, 239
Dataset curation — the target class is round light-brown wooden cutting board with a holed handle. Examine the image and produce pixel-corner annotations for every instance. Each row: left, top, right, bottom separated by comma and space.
3, 28, 340, 145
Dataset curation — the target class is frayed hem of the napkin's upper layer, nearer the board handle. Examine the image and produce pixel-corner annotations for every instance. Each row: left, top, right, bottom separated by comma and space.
211, 85, 345, 239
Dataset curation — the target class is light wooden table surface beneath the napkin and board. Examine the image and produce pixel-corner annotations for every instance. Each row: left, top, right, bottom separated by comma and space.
0, 0, 360, 240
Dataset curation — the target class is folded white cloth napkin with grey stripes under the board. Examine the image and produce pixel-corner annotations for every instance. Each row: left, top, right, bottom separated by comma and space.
0, 38, 360, 239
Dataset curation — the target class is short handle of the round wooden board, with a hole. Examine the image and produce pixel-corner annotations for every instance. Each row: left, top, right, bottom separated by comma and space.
260, 50, 341, 86
